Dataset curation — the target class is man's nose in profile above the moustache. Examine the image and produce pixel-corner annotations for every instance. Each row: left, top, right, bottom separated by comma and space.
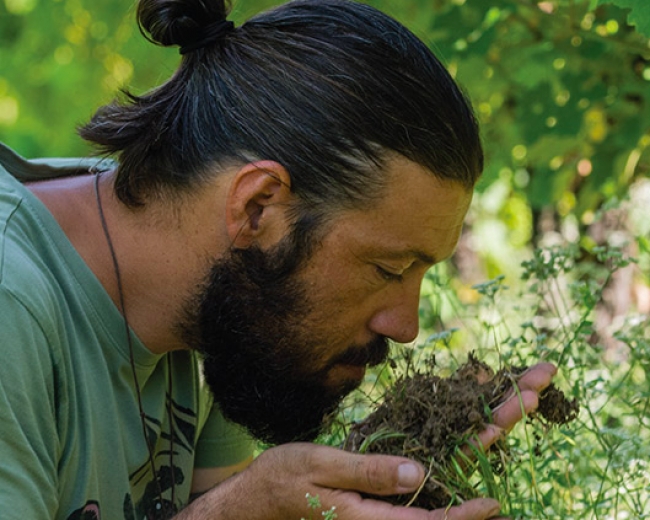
369, 283, 420, 343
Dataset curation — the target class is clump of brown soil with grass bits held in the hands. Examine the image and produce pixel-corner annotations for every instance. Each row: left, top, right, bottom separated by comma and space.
343, 355, 578, 509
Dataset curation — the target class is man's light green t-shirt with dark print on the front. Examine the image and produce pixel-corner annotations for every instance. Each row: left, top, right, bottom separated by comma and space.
0, 145, 252, 520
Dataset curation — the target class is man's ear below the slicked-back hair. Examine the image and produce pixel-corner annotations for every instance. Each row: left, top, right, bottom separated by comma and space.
225, 161, 295, 249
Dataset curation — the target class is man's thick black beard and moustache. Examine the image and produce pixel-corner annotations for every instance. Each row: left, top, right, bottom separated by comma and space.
180, 232, 389, 444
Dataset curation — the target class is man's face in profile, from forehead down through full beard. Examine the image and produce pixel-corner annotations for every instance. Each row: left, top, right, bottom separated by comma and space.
183, 159, 471, 443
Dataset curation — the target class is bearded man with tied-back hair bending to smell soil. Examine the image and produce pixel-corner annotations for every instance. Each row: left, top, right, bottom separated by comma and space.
0, 0, 555, 520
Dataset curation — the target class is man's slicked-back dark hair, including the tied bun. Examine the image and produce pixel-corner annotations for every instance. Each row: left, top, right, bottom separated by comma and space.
80, 0, 483, 213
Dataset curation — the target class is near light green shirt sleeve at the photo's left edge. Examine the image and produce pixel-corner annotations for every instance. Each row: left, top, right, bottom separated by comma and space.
0, 288, 58, 520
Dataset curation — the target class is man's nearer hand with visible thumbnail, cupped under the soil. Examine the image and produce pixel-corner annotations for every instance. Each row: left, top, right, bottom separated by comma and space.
175, 443, 506, 520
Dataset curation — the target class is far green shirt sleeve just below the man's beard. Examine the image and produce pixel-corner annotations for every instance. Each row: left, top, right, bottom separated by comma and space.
194, 387, 255, 468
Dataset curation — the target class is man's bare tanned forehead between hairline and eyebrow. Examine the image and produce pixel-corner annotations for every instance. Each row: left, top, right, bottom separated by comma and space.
332, 157, 472, 263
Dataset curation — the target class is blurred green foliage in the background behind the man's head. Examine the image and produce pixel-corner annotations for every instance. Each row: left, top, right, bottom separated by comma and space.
0, 0, 650, 229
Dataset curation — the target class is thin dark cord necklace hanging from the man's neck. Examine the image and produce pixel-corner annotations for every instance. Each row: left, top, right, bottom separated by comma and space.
94, 172, 176, 518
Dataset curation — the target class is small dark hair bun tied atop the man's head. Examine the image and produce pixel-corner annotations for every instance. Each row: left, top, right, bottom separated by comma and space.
137, 0, 230, 48
